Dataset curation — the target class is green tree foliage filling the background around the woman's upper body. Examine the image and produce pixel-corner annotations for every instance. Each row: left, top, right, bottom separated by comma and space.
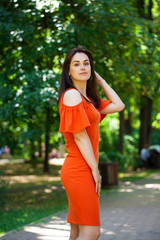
0, 0, 160, 168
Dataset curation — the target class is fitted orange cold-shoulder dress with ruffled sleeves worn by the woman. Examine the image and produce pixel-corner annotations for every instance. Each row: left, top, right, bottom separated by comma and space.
59, 89, 111, 226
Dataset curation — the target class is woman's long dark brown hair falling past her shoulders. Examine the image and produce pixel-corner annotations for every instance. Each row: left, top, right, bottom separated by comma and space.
58, 46, 100, 108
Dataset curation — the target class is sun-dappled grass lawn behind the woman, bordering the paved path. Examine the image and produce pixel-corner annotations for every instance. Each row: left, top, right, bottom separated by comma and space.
0, 163, 159, 234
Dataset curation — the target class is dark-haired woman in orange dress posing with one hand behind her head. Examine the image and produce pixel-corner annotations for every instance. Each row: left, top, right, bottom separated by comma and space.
59, 47, 125, 240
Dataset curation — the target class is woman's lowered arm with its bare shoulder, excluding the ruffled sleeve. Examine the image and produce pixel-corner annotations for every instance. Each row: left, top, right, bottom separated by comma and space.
63, 89, 101, 195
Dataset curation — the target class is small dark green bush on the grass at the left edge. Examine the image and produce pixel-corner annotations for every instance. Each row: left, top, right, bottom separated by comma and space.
0, 173, 9, 210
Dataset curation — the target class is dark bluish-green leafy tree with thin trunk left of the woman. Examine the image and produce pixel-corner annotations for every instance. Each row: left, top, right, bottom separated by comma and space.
0, 0, 59, 171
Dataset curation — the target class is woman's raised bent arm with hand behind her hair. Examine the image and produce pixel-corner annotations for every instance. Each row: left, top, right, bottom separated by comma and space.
95, 72, 125, 114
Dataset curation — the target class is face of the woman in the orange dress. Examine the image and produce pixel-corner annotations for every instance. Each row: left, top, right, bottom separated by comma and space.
69, 52, 91, 83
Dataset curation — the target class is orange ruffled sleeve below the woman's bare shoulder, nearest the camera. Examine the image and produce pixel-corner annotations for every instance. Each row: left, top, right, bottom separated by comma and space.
59, 101, 91, 133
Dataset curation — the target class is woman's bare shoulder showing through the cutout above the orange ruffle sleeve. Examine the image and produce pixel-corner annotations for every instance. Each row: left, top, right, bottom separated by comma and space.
63, 89, 82, 106
